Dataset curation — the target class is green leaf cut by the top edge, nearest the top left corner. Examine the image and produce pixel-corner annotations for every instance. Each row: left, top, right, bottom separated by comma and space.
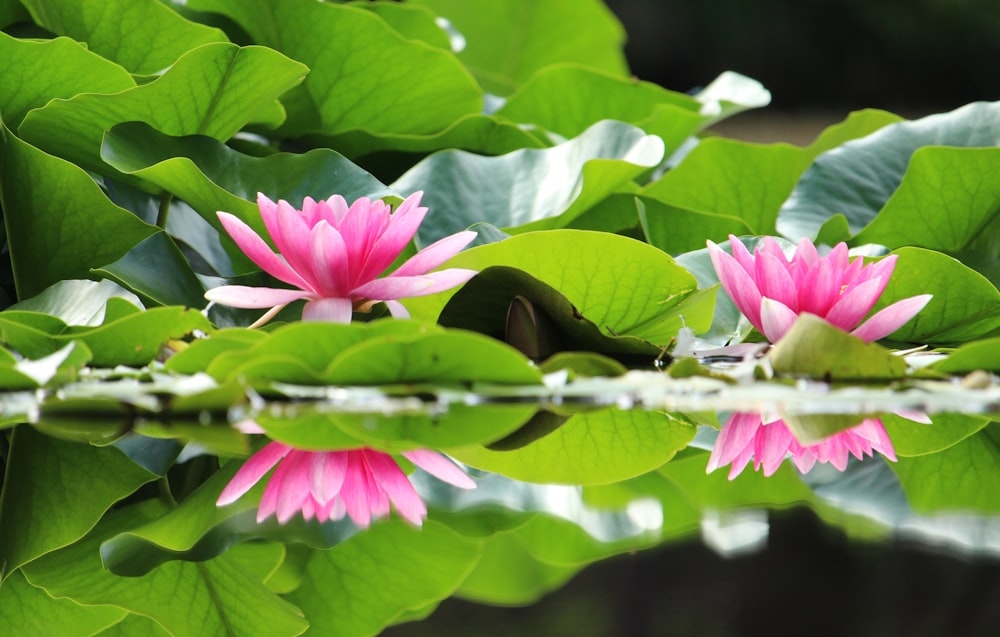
22, 0, 226, 74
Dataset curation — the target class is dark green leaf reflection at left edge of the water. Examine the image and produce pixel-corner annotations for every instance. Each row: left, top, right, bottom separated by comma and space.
0, 425, 156, 577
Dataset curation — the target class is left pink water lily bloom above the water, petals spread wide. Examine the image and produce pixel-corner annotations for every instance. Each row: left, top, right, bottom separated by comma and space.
205, 192, 476, 324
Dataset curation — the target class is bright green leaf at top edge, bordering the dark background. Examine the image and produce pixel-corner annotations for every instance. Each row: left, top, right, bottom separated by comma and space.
408, 0, 628, 95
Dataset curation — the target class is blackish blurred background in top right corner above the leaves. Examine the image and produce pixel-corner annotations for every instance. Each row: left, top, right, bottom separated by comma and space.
606, 0, 1000, 113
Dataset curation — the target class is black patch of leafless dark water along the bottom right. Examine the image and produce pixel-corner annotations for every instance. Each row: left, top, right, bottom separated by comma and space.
383, 508, 1000, 637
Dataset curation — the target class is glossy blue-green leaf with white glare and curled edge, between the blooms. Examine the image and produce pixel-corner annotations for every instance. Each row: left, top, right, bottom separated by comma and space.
392, 121, 663, 245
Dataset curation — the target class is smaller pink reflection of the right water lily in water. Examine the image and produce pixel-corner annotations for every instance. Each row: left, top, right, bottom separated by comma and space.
706, 413, 919, 480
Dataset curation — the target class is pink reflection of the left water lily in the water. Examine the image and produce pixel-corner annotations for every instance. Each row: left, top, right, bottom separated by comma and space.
216, 442, 476, 528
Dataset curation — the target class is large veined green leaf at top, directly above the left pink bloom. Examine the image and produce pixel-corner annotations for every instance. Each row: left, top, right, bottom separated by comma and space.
187, 0, 482, 136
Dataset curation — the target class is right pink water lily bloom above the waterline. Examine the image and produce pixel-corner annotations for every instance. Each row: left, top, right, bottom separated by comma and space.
708, 235, 931, 343
